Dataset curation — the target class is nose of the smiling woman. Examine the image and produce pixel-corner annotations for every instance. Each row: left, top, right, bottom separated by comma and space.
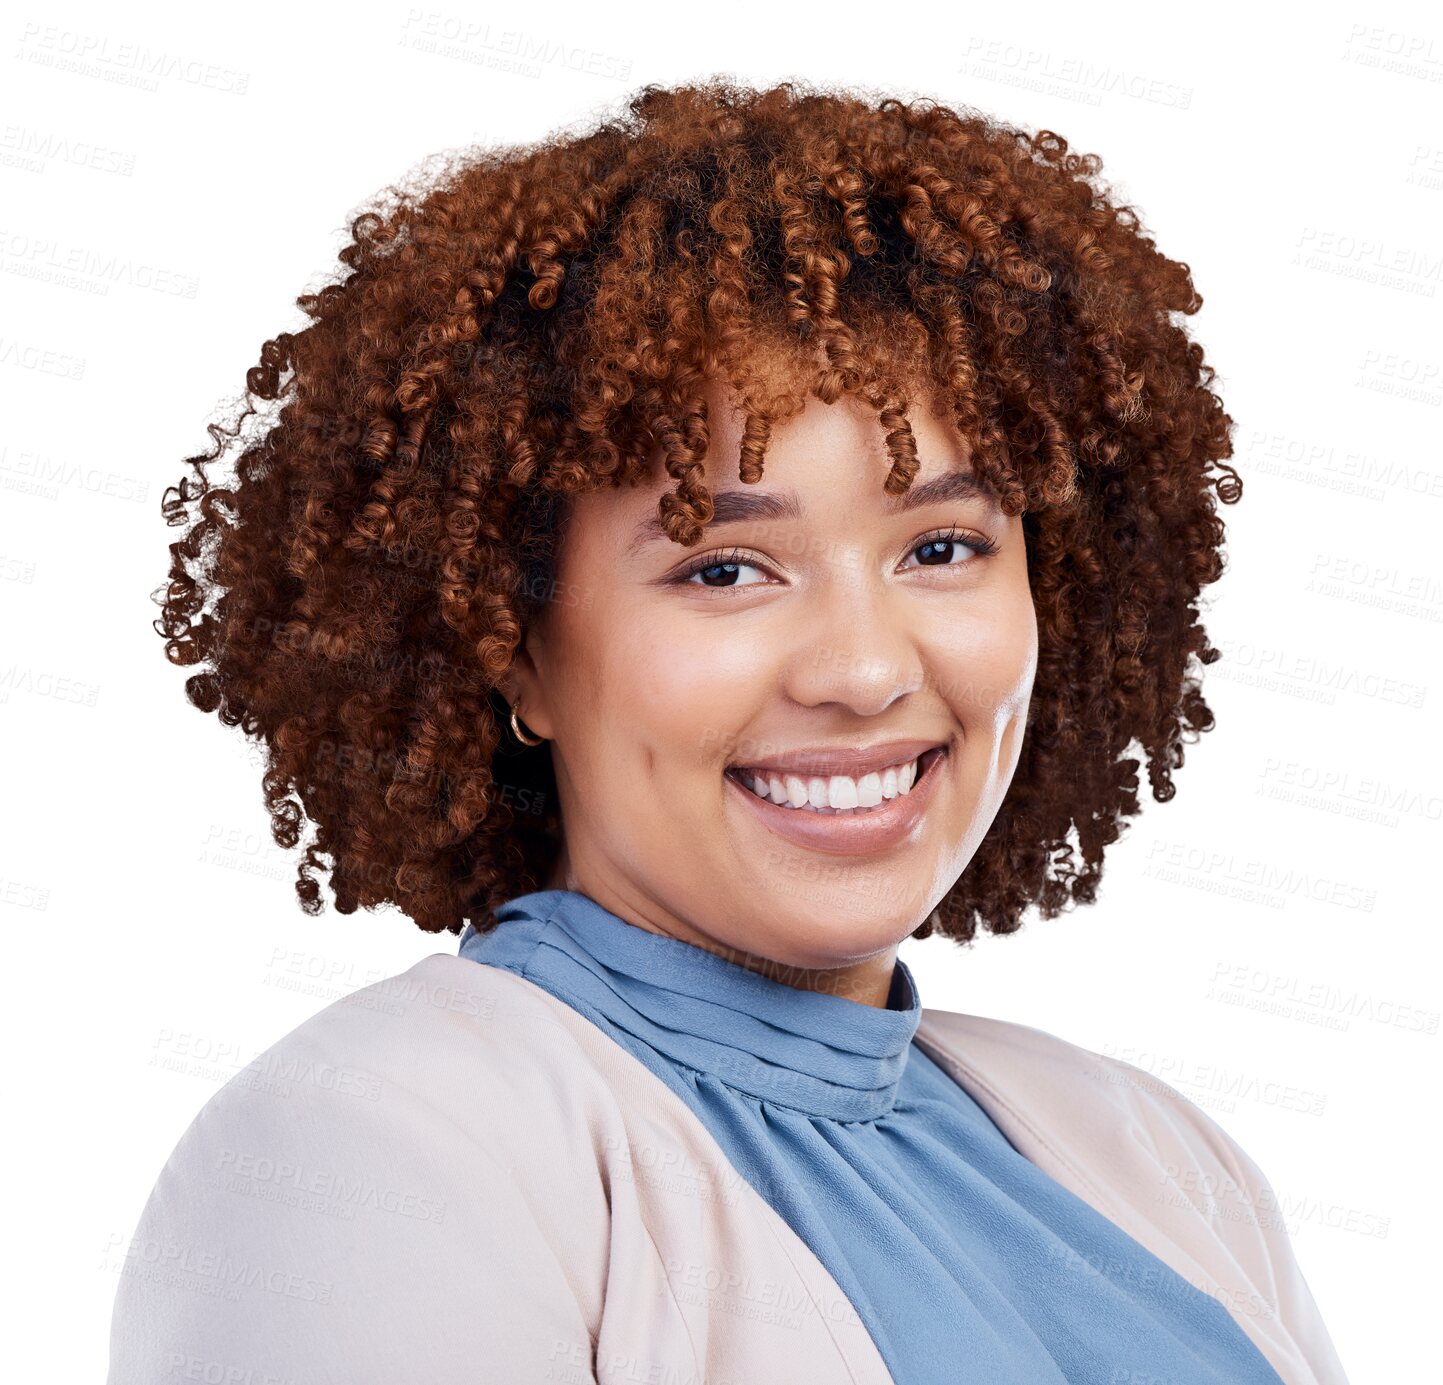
785, 562, 926, 717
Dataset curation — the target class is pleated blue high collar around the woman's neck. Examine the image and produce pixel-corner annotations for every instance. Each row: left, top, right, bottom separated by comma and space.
459, 890, 922, 1121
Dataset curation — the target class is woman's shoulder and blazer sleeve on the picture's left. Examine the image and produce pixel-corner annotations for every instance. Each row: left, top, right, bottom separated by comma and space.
108, 954, 606, 1385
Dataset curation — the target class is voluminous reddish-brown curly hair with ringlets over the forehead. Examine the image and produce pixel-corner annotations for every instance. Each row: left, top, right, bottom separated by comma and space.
153, 78, 1241, 942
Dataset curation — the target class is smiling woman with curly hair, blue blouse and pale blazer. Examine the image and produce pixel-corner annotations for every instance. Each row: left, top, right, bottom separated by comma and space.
110, 82, 1343, 1385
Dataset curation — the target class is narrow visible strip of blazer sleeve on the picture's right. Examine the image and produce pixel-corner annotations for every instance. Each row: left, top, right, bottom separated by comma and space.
1126, 1065, 1348, 1385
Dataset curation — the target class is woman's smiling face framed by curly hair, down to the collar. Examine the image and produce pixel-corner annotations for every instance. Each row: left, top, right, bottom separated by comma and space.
502, 367, 1038, 1006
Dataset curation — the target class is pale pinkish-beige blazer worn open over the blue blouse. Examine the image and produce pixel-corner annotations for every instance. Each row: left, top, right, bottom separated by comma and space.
108, 952, 1346, 1385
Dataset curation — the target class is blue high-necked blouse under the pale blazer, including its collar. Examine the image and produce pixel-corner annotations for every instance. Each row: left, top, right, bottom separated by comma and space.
460, 890, 1281, 1385
